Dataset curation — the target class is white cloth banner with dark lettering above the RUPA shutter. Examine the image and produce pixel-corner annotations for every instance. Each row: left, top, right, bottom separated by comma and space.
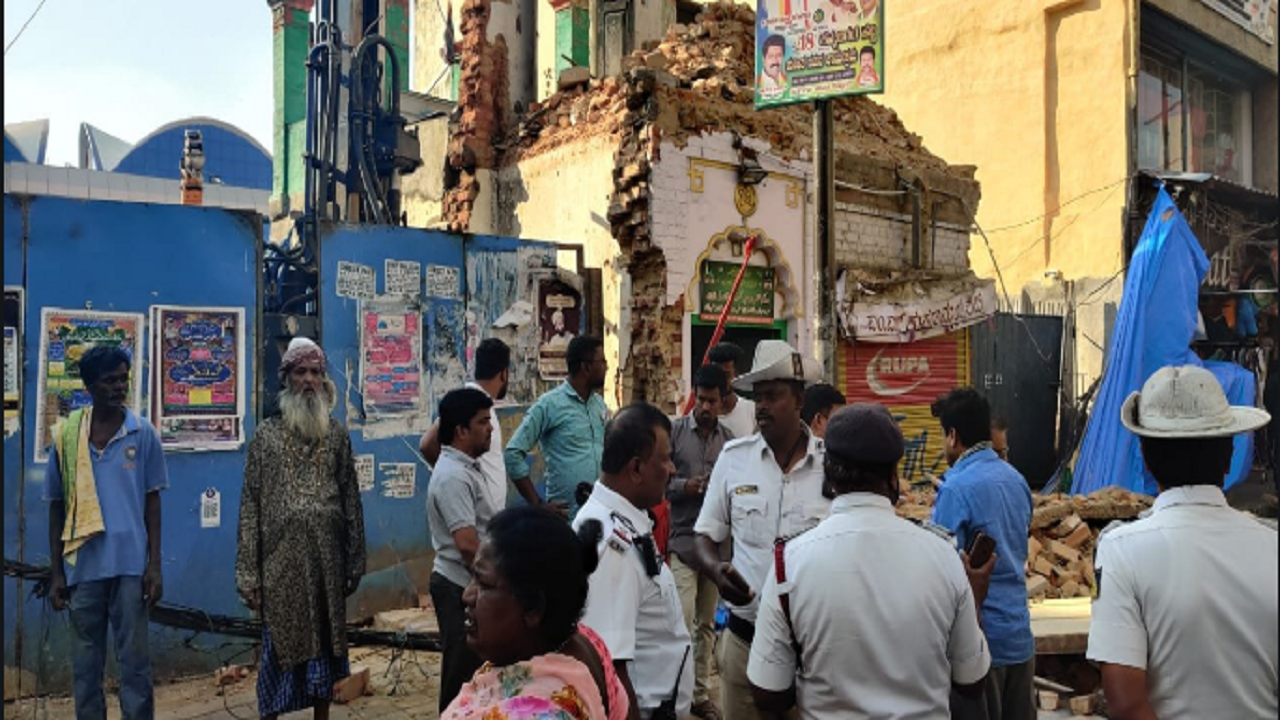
841, 282, 1000, 342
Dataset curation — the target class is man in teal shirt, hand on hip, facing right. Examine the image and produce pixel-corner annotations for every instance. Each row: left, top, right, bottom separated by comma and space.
503, 336, 609, 519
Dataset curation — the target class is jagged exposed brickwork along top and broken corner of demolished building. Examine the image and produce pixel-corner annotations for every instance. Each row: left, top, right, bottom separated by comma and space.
503, 0, 977, 410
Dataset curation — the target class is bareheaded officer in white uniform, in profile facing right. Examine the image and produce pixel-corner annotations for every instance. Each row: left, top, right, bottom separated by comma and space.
573, 404, 694, 719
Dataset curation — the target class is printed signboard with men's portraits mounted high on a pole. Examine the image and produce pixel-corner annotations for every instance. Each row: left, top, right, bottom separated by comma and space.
755, 0, 884, 108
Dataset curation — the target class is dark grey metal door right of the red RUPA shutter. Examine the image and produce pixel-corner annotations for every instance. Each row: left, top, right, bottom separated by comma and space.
972, 313, 1062, 489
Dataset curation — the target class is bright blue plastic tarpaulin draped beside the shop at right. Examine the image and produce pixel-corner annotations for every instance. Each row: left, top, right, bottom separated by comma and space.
1071, 187, 1257, 495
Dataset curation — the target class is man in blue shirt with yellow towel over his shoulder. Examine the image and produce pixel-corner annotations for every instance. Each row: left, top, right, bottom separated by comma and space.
45, 346, 169, 720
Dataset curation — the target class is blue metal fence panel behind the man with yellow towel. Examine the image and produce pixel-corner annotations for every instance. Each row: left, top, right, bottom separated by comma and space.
4, 196, 262, 689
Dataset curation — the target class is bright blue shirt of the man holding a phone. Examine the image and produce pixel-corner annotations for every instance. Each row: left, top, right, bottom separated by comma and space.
933, 446, 1036, 666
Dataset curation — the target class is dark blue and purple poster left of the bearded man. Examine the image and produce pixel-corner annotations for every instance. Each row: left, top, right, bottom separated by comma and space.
151, 306, 244, 450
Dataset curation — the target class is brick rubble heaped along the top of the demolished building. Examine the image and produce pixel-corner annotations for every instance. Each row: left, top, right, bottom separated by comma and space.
507, 0, 966, 177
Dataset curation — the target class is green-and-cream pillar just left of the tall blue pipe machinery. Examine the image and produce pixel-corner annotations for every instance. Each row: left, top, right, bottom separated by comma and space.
268, 0, 315, 206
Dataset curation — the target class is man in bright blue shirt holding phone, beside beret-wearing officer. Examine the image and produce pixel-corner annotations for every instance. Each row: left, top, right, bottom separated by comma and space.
933, 388, 1036, 720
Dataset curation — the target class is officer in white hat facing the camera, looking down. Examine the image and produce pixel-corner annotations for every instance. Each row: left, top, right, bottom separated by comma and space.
694, 340, 831, 720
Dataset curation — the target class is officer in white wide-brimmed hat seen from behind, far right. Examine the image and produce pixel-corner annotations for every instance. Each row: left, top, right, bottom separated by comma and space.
1088, 365, 1280, 720
